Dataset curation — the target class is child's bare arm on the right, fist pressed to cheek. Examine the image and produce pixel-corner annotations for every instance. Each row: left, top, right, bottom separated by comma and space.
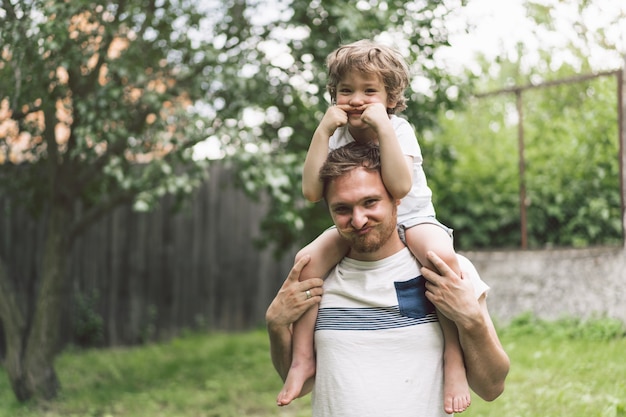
362, 103, 413, 199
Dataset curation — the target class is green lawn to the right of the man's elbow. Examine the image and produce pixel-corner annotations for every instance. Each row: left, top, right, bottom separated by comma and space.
463, 316, 626, 417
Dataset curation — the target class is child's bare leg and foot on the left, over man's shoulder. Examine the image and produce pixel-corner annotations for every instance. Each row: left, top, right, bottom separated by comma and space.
276, 229, 348, 405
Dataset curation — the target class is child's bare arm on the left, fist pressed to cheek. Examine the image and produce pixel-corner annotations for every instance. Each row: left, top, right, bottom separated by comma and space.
302, 105, 350, 202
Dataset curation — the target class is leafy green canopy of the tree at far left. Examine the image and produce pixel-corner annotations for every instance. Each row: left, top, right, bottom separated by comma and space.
0, 0, 215, 224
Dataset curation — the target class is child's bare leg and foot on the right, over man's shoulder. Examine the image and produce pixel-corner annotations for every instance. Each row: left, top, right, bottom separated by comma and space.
406, 223, 471, 413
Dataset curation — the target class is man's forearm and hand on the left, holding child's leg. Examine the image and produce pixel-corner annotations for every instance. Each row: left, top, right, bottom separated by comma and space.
265, 255, 324, 381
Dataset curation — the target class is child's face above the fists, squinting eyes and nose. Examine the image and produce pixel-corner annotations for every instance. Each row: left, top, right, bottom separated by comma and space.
337, 70, 395, 108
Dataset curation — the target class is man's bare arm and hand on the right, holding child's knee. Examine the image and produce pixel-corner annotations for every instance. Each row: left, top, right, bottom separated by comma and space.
422, 252, 510, 401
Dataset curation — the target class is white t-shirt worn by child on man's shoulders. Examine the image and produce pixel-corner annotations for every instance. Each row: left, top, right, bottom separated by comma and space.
328, 115, 435, 219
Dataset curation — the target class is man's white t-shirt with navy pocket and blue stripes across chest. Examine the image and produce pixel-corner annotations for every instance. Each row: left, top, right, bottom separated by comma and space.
313, 248, 488, 417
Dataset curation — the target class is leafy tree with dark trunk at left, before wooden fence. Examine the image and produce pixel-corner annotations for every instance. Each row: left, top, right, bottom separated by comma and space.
0, 0, 216, 401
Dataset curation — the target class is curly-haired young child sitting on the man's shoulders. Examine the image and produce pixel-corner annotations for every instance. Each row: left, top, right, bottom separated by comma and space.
277, 40, 470, 413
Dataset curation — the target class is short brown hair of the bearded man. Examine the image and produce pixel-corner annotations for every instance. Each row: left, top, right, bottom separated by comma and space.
319, 142, 380, 198
